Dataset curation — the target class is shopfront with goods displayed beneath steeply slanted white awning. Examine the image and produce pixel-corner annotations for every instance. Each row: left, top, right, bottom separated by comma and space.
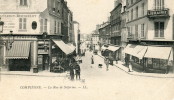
50, 39, 75, 72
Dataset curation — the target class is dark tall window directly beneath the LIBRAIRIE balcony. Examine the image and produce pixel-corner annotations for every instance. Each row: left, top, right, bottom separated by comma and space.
155, 22, 164, 37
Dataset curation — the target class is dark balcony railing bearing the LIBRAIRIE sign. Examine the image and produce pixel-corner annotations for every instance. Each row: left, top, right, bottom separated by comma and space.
147, 9, 169, 18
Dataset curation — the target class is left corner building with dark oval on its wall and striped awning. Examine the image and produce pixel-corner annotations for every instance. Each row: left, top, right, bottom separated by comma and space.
0, 0, 74, 71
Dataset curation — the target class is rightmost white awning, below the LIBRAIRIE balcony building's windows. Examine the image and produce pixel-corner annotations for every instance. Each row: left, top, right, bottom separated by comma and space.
144, 46, 172, 60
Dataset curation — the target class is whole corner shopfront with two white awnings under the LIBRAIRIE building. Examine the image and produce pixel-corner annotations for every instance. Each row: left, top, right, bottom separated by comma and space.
124, 44, 173, 73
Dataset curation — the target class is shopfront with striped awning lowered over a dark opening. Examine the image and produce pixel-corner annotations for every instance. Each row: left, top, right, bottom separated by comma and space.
5, 41, 31, 71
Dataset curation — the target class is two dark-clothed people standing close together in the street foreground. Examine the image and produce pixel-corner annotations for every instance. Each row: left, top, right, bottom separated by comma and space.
69, 61, 81, 80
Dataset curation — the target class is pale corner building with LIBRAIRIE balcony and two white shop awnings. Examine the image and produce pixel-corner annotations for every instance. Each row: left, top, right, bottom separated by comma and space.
125, 0, 174, 72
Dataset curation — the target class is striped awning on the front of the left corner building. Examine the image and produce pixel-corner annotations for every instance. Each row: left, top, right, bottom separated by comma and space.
6, 41, 30, 59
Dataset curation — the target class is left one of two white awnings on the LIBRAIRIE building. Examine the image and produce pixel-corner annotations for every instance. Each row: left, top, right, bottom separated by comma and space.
124, 44, 147, 59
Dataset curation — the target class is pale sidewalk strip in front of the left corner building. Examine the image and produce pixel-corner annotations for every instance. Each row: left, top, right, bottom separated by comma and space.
0, 71, 69, 77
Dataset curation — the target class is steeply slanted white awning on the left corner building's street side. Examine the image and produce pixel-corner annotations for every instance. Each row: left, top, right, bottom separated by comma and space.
53, 40, 73, 55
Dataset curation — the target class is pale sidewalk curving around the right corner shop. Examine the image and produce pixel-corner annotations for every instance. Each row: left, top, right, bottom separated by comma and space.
98, 52, 174, 78
